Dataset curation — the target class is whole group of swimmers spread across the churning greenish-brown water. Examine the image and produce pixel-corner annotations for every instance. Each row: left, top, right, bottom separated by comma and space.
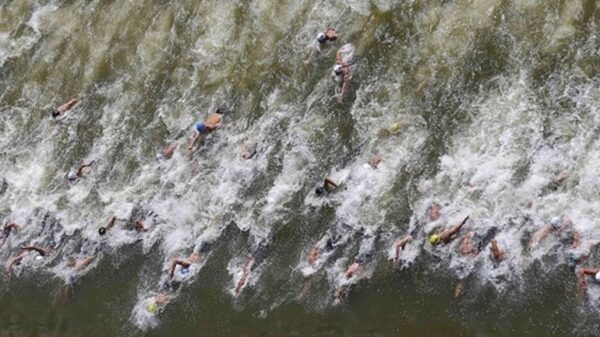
0, 28, 600, 313
